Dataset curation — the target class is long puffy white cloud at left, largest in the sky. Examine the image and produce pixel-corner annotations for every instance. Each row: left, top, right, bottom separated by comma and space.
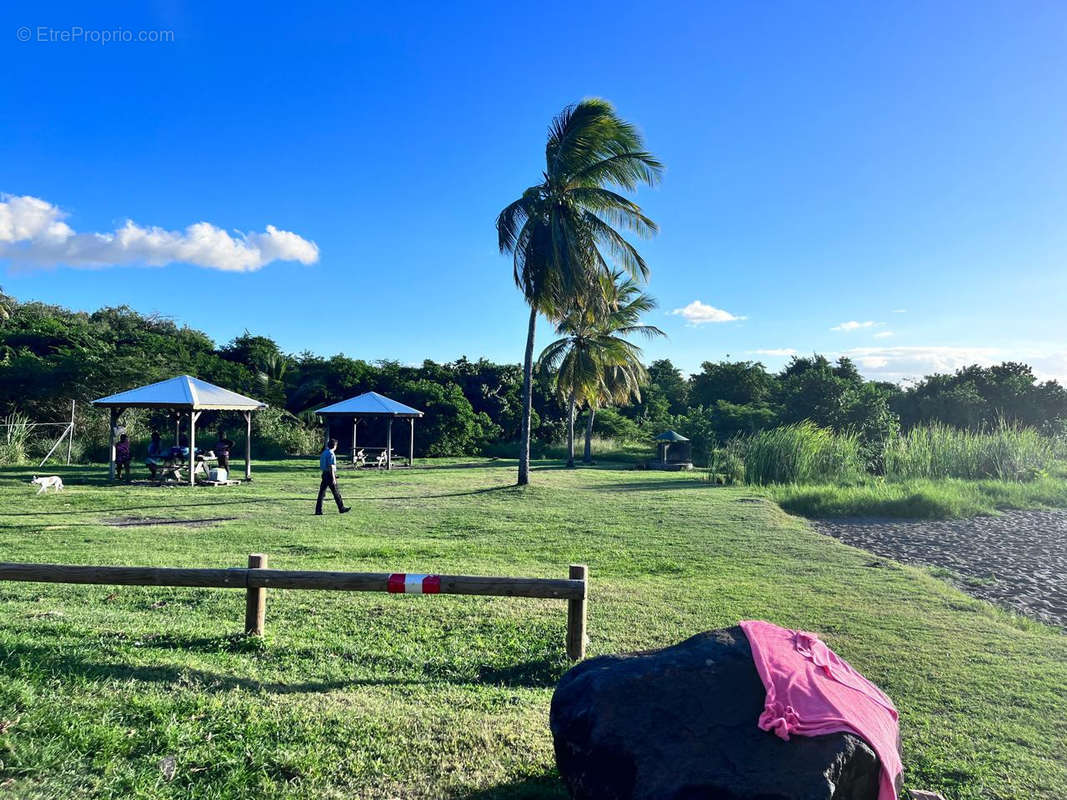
0, 194, 319, 272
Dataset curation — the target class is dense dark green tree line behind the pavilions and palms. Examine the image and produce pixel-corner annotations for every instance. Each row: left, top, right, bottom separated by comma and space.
0, 298, 1067, 471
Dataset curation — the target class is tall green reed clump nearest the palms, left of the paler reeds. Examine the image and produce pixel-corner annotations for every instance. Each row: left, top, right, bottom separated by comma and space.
737, 421, 863, 484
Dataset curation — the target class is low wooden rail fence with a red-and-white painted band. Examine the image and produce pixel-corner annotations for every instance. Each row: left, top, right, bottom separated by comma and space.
0, 553, 589, 660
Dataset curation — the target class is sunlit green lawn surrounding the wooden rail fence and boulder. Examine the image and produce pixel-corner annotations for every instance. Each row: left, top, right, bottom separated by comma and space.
0, 462, 1067, 800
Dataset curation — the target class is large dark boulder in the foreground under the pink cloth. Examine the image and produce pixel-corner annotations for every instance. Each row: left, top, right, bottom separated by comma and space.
551, 627, 879, 800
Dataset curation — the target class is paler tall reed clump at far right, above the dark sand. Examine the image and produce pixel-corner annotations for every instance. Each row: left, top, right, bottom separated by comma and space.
886, 421, 1056, 481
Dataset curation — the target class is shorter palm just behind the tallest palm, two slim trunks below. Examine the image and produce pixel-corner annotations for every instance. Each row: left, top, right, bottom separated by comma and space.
538, 271, 664, 467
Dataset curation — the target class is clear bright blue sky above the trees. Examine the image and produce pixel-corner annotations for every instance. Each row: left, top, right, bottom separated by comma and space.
0, 0, 1067, 380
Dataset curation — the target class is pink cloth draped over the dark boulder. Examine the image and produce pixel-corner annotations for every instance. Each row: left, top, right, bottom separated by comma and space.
740, 620, 904, 800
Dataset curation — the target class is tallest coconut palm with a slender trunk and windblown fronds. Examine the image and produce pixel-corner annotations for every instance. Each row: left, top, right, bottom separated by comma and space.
496, 99, 663, 485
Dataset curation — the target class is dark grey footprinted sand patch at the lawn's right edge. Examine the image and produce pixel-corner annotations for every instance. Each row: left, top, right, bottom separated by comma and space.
813, 511, 1067, 627
